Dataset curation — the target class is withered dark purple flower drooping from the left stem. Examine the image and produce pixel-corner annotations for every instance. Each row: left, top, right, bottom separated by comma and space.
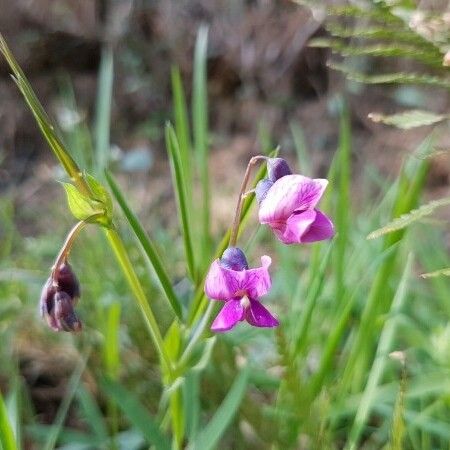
39, 262, 82, 331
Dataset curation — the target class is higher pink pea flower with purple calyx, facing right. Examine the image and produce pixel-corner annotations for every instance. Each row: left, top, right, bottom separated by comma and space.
255, 158, 334, 244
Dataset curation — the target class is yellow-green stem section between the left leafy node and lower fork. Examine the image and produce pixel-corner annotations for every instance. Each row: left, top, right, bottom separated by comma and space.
106, 228, 172, 375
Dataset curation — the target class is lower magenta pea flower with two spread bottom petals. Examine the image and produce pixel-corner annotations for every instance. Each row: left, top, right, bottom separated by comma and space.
205, 247, 278, 333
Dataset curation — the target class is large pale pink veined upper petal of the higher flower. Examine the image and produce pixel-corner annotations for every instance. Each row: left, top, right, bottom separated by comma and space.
259, 175, 328, 224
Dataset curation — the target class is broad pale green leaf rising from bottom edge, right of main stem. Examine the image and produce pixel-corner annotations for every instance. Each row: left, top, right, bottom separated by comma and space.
188, 367, 250, 450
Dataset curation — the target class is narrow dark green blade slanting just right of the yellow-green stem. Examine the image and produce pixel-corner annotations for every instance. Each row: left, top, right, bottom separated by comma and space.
106, 172, 182, 320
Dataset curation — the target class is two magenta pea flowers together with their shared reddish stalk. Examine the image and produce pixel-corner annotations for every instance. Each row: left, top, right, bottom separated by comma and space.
205, 157, 334, 332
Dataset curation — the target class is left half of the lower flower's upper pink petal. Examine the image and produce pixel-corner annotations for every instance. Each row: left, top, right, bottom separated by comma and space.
205, 259, 239, 301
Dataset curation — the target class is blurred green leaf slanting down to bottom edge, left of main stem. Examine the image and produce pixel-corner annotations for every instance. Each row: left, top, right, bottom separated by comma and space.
100, 379, 170, 450
